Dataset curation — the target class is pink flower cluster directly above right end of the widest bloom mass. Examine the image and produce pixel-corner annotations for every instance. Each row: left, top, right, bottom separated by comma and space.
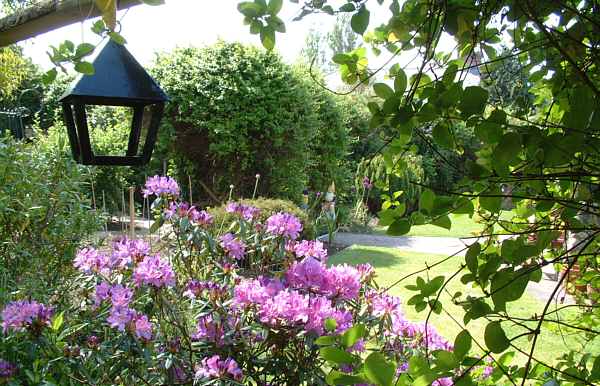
286, 257, 361, 299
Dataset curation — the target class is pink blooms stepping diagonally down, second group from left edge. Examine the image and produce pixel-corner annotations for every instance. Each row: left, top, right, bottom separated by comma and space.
95, 282, 152, 340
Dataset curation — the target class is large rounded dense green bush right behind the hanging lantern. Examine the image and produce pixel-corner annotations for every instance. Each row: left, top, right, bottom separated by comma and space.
153, 42, 344, 199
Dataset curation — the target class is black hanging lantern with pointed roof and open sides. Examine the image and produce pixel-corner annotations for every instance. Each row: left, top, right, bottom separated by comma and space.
60, 40, 169, 166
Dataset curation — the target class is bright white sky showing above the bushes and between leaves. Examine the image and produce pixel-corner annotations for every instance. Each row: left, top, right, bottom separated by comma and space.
16, 0, 464, 83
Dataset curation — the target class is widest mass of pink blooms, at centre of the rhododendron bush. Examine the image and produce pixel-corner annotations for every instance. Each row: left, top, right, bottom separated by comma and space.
233, 278, 352, 335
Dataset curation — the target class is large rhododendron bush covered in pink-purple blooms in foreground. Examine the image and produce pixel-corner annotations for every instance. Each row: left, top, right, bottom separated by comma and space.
0, 177, 493, 385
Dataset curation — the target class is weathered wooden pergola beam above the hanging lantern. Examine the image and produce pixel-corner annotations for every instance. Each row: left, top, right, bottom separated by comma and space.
0, 0, 141, 47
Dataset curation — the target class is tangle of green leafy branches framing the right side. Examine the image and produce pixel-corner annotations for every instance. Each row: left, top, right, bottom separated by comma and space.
239, 0, 600, 385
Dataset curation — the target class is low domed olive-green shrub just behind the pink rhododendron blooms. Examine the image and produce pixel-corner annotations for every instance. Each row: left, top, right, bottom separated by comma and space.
209, 197, 315, 239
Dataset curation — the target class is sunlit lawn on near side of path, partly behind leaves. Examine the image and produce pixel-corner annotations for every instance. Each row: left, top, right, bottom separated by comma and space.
329, 246, 600, 363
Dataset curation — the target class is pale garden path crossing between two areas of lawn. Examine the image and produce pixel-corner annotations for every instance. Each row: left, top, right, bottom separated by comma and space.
330, 232, 575, 304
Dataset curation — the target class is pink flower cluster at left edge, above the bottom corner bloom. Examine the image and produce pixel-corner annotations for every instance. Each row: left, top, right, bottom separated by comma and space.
2, 300, 53, 332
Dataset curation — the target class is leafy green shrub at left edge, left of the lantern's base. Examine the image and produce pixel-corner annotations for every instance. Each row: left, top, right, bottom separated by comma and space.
0, 138, 100, 299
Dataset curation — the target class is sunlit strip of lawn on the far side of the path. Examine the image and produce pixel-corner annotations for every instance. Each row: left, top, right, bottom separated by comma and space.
373, 211, 513, 237
